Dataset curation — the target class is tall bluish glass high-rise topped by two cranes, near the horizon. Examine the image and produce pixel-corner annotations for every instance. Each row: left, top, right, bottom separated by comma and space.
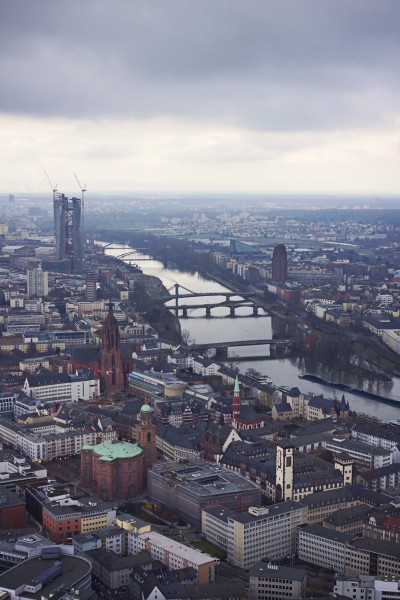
53, 192, 83, 271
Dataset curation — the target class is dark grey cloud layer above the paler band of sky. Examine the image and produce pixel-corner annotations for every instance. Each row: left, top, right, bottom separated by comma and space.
0, 0, 400, 130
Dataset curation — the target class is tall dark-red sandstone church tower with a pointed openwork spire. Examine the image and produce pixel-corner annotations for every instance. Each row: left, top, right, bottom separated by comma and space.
100, 302, 124, 393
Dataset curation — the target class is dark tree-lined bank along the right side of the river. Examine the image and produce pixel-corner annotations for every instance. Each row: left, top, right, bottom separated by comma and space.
98, 231, 398, 379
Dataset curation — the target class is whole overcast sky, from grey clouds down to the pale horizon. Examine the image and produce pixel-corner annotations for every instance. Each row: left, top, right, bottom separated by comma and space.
0, 0, 400, 194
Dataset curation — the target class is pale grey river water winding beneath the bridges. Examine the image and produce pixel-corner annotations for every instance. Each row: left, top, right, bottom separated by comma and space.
99, 242, 400, 421
